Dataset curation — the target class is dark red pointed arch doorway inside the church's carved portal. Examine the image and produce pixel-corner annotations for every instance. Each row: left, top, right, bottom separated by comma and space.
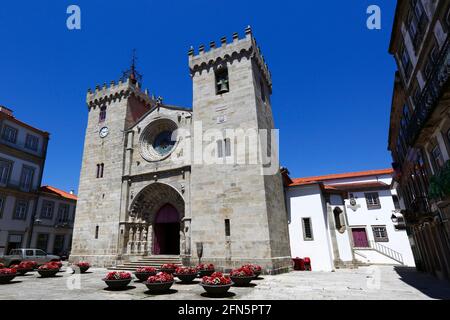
153, 203, 181, 255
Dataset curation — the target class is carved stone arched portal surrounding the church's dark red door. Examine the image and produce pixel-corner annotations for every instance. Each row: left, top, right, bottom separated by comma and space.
124, 182, 185, 255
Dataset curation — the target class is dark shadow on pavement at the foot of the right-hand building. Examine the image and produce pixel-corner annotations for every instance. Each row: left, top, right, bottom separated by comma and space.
394, 266, 450, 300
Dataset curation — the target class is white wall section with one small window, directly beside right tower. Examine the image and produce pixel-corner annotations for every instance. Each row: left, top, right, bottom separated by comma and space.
287, 184, 333, 271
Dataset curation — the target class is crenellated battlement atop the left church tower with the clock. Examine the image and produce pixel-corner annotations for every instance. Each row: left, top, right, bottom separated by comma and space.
86, 79, 158, 109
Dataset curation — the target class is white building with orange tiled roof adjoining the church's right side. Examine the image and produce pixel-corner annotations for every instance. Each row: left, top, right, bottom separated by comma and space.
285, 169, 414, 271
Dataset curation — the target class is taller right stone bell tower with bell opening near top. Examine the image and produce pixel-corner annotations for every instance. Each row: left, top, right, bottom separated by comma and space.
189, 27, 291, 273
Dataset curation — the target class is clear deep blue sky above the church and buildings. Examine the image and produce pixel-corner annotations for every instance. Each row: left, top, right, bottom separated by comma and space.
0, 0, 396, 190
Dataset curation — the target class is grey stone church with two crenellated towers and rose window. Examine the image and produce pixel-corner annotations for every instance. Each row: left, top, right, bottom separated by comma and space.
71, 27, 291, 273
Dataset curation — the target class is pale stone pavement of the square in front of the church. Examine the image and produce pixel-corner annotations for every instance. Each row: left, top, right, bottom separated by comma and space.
0, 266, 450, 300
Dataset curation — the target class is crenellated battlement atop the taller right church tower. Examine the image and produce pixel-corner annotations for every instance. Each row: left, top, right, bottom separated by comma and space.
188, 26, 272, 90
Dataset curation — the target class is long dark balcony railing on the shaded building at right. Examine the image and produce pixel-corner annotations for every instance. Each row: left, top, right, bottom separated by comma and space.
406, 40, 450, 146
